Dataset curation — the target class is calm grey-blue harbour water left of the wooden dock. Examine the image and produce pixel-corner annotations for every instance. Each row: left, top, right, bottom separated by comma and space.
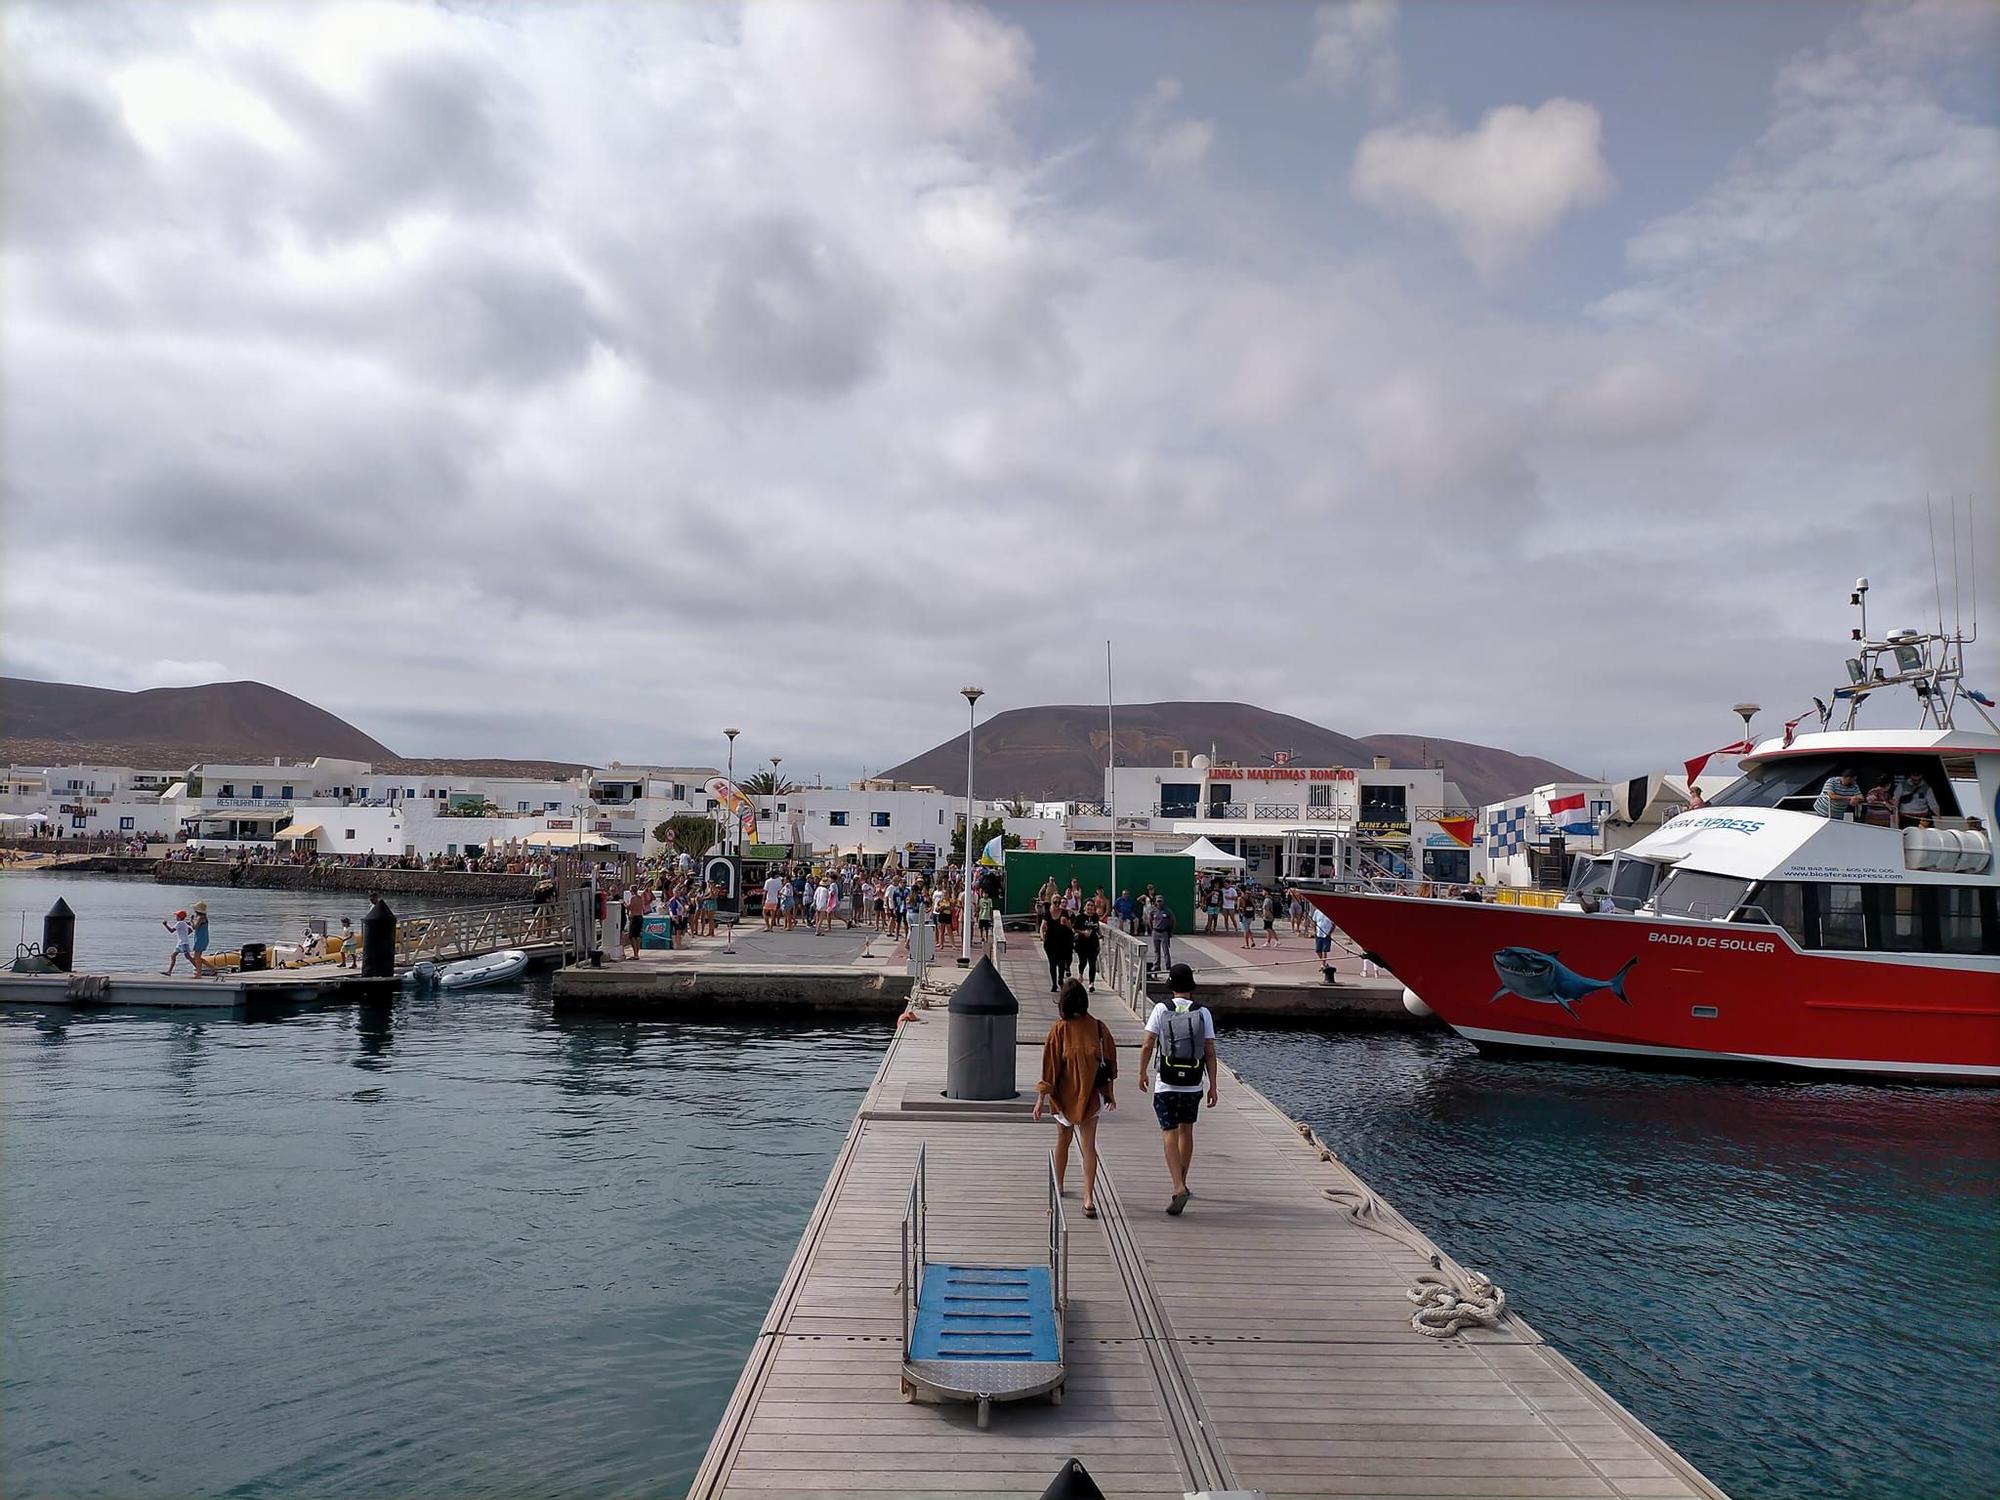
0, 878, 890, 1500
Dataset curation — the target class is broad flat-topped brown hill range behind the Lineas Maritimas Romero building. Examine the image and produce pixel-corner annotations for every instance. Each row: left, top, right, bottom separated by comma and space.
880, 702, 1574, 804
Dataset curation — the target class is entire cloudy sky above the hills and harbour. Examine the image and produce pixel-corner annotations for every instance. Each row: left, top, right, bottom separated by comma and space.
0, 0, 2000, 776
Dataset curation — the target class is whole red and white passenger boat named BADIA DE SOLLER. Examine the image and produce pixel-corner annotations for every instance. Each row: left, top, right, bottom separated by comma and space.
1306, 616, 2000, 1084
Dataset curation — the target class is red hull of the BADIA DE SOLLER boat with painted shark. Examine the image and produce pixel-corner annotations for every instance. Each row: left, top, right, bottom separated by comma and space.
1310, 892, 2000, 1084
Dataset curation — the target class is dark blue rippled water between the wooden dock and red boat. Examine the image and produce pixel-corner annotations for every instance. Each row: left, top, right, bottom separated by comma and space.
1222, 1030, 2000, 1500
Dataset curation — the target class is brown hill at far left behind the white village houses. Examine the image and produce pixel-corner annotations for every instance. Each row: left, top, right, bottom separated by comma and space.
0, 678, 394, 768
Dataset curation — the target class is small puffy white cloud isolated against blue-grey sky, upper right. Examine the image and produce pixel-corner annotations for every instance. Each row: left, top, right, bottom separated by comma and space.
1350, 98, 1614, 276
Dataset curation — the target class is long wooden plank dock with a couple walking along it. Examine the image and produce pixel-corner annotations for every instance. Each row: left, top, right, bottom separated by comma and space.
690, 944, 1722, 1500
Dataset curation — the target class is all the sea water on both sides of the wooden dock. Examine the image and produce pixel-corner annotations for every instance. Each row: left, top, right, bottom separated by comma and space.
0, 876, 2000, 1500
